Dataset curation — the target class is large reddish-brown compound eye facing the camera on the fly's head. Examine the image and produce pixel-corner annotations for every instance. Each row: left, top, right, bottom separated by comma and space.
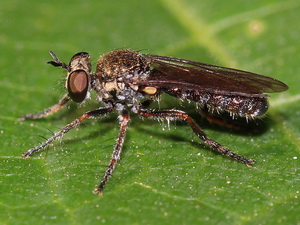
67, 70, 89, 102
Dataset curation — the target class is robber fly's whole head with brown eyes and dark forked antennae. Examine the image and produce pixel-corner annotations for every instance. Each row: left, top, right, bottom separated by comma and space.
48, 52, 91, 103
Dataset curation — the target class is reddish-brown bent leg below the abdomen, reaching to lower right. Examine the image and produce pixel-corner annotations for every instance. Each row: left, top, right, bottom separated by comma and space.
138, 109, 254, 166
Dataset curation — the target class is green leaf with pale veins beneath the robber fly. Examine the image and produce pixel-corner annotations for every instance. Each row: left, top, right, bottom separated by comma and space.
0, 0, 300, 224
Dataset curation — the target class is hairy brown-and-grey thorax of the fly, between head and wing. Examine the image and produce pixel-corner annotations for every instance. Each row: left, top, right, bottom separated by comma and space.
94, 49, 150, 102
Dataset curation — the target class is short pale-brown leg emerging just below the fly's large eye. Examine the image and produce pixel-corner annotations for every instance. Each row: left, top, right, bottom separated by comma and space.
19, 94, 70, 120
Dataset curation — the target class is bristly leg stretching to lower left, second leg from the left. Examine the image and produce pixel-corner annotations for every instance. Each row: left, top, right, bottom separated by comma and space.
23, 108, 114, 158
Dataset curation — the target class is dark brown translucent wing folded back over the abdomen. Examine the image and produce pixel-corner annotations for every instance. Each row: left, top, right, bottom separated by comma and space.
144, 55, 288, 97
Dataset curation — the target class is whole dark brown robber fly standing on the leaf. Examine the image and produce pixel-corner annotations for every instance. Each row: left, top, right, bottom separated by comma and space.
20, 49, 288, 194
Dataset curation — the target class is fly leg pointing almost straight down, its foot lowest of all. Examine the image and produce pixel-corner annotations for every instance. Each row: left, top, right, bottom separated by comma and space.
95, 111, 130, 195
